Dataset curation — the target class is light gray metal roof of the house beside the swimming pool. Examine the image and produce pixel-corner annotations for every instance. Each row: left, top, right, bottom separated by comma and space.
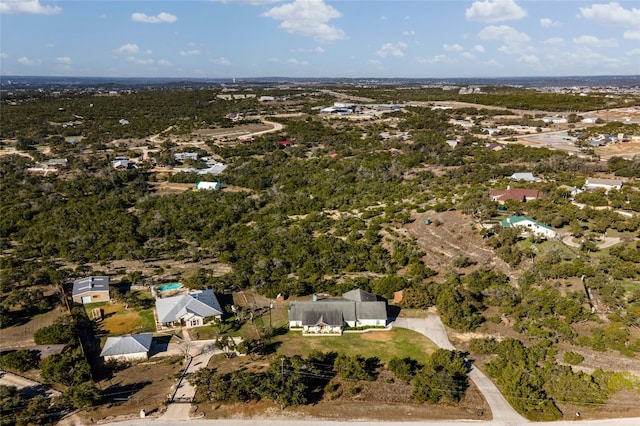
156, 290, 222, 323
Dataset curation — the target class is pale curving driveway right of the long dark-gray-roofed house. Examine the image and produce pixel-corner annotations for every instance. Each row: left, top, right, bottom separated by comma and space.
393, 315, 528, 425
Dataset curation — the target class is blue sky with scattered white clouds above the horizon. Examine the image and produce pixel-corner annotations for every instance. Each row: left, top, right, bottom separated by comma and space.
0, 0, 640, 78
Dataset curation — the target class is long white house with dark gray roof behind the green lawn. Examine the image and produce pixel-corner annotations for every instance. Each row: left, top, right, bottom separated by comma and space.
289, 289, 387, 335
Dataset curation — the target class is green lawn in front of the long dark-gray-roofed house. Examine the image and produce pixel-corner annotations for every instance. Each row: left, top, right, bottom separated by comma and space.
273, 328, 437, 363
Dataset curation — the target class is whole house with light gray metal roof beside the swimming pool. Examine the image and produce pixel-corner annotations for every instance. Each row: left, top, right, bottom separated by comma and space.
156, 290, 222, 327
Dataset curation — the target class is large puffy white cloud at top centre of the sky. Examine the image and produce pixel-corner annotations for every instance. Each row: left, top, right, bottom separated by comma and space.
263, 0, 347, 41
